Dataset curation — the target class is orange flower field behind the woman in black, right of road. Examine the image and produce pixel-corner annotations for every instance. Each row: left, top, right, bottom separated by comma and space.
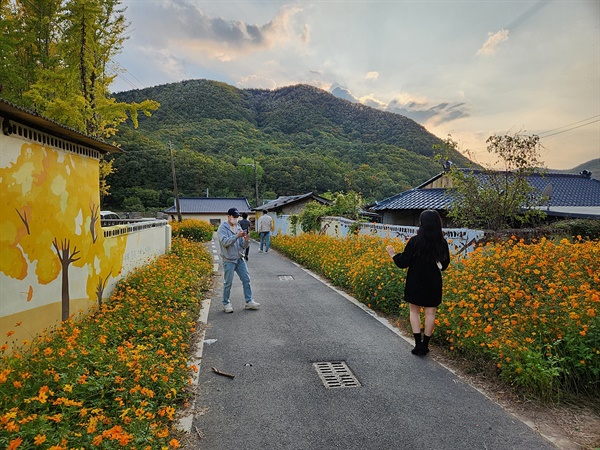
272, 234, 600, 400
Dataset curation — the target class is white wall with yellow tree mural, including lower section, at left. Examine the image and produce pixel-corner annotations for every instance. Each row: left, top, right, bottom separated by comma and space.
0, 127, 170, 352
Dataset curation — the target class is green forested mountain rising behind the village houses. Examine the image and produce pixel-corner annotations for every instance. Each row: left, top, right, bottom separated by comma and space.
104, 80, 468, 210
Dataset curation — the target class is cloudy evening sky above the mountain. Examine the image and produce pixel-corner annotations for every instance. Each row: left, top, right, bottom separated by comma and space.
111, 0, 600, 169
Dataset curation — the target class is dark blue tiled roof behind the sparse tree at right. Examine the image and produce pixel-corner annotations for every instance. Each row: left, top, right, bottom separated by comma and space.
371, 169, 600, 214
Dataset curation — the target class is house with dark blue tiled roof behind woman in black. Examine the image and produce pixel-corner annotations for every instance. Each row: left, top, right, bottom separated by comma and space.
369, 169, 600, 226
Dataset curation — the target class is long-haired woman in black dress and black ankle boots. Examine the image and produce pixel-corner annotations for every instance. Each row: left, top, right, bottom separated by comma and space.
386, 210, 450, 356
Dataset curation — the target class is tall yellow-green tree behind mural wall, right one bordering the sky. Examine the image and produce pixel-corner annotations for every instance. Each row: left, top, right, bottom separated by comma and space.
25, 0, 159, 138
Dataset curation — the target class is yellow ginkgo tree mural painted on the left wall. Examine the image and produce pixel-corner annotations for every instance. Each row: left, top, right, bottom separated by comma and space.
0, 143, 127, 326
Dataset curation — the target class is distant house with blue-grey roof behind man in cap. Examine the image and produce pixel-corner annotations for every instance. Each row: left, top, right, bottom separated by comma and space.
163, 197, 254, 226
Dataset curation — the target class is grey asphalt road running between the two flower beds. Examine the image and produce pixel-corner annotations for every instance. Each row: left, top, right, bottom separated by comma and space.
193, 237, 555, 450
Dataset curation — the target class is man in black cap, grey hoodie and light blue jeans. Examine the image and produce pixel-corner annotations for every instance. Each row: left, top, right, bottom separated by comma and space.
217, 208, 260, 313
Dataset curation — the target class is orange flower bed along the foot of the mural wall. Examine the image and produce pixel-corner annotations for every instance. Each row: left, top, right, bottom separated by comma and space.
0, 238, 212, 450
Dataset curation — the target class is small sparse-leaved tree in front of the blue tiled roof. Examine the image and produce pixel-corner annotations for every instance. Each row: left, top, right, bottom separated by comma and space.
446, 134, 545, 230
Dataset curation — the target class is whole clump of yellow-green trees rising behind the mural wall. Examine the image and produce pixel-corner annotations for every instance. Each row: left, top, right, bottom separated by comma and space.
7, 0, 159, 205
